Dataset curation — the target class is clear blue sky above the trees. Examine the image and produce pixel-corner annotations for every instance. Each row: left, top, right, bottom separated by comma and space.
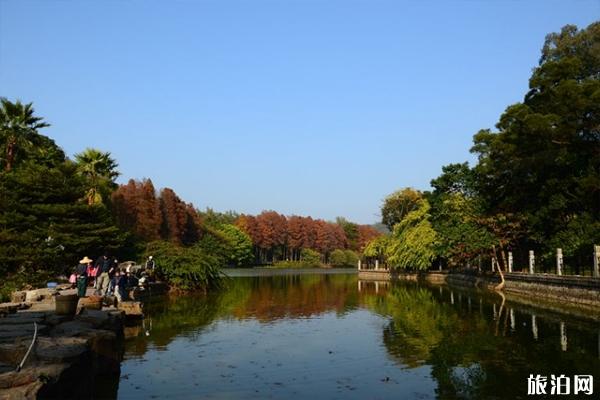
0, 0, 600, 223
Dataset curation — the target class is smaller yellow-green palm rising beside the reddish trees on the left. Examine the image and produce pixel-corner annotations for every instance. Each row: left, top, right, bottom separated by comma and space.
75, 148, 120, 205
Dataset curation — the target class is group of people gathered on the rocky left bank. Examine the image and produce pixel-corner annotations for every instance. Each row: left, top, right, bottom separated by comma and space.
69, 253, 155, 301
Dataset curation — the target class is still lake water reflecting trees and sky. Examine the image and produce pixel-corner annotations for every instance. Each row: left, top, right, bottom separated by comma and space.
117, 273, 600, 399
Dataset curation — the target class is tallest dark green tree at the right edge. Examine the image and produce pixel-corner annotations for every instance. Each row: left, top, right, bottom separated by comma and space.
471, 22, 600, 266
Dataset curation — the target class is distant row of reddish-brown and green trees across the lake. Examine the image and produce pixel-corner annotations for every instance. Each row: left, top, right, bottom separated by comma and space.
111, 179, 381, 266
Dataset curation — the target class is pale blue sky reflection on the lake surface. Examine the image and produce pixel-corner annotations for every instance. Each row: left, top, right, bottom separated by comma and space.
119, 310, 435, 399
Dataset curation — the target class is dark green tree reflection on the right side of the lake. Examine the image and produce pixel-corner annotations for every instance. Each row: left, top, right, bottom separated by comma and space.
362, 283, 600, 399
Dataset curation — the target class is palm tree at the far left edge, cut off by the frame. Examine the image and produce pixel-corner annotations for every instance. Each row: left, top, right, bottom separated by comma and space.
0, 97, 50, 171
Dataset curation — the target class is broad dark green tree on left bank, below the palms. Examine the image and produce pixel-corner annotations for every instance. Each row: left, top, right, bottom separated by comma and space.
0, 161, 128, 274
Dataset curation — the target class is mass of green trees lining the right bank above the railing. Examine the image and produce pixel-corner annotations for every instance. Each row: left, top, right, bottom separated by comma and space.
365, 23, 600, 272
